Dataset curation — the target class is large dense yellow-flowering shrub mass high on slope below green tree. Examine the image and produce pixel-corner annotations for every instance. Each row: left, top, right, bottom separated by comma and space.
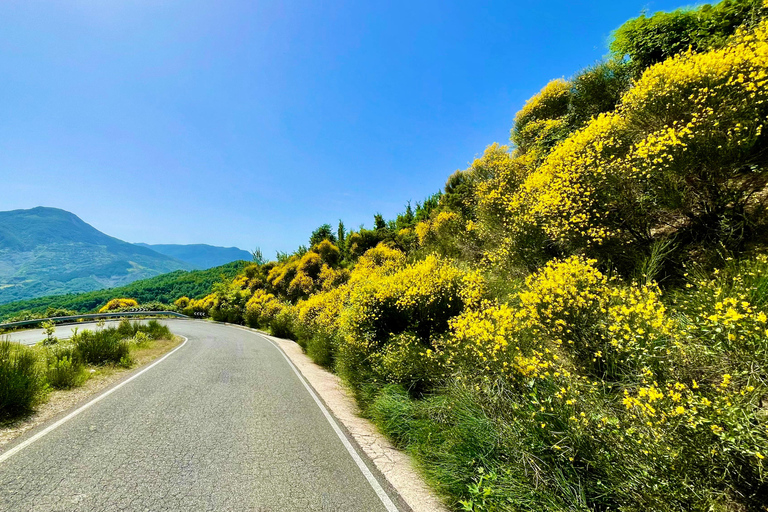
479, 22, 768, 268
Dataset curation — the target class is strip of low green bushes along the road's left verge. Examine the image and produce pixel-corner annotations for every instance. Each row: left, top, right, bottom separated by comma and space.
0, 320, 173, 421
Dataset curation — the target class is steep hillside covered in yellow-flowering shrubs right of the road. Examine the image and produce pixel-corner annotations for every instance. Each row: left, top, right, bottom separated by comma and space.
138, 0, 768, 511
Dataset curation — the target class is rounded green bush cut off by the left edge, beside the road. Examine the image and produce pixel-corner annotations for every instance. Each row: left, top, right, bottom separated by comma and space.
0, 340, 44, 418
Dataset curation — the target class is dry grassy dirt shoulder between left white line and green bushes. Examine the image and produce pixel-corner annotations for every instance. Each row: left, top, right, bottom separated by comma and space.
0, 336, 184, 447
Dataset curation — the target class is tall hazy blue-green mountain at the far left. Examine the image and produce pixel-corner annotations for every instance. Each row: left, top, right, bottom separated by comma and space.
0, 207, 193, 304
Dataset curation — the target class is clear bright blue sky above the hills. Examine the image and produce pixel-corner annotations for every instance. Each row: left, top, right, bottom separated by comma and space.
0, 0, 680, 256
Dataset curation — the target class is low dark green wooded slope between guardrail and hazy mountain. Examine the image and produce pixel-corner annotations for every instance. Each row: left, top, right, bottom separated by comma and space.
0, 261, 249, 321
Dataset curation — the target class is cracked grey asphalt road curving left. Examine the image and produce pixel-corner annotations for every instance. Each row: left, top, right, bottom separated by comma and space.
0, 321, 392, 512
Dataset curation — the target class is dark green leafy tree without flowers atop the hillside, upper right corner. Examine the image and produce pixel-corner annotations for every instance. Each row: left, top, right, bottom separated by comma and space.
610, 0, 766, 72
